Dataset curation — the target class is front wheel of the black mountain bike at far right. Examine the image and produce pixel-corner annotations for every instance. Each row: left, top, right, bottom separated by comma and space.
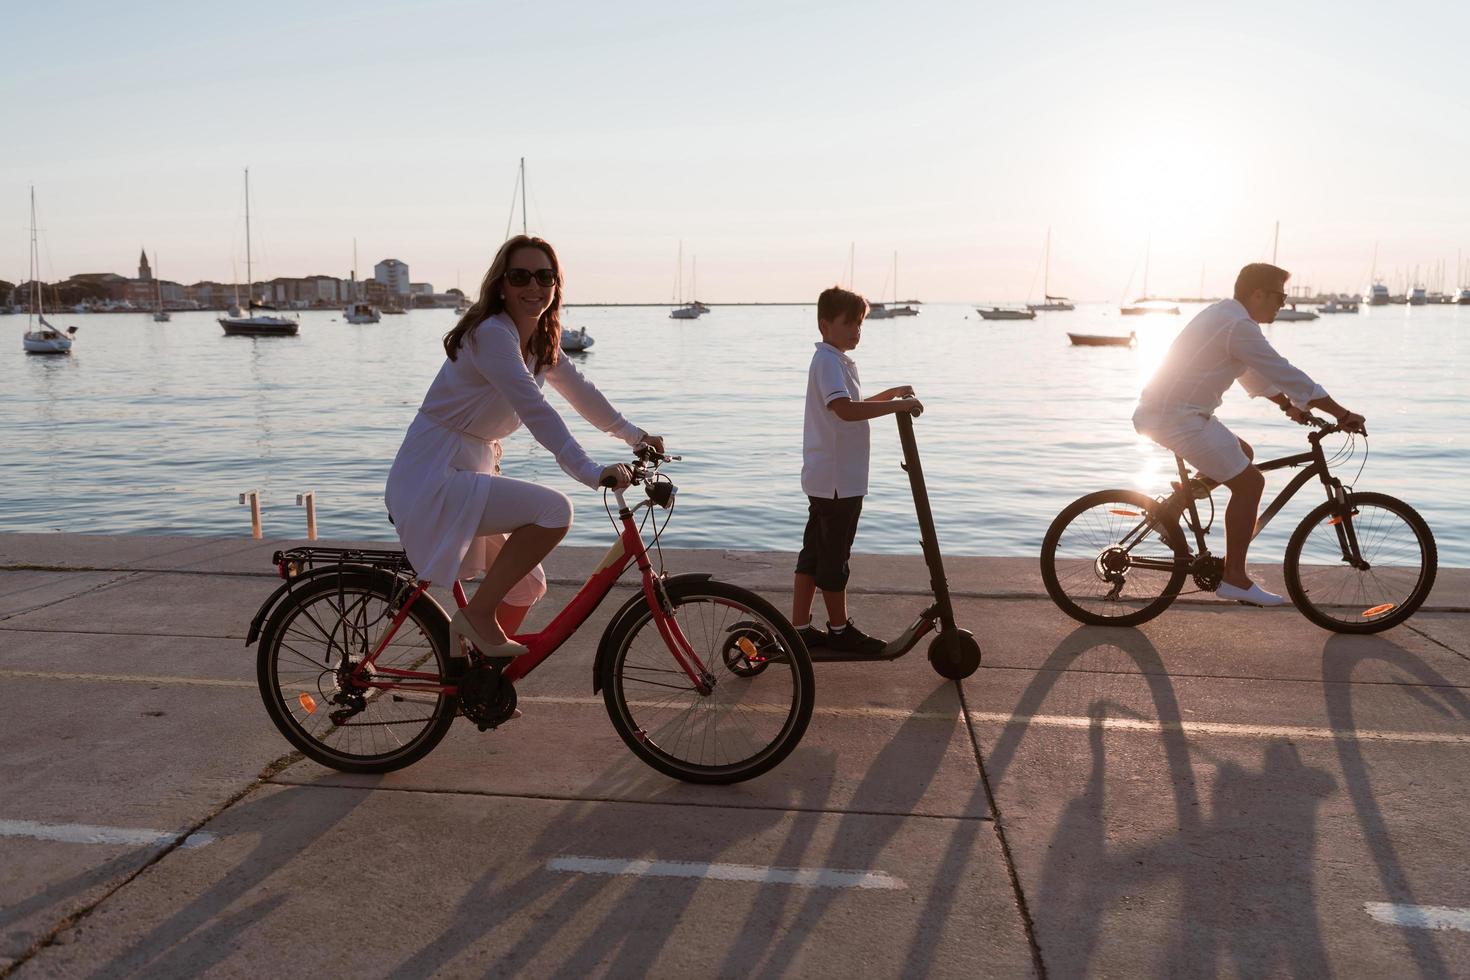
1282, 494, 1439, 633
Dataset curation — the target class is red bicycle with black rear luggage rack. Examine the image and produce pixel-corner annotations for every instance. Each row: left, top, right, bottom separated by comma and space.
245, 447, 814, 783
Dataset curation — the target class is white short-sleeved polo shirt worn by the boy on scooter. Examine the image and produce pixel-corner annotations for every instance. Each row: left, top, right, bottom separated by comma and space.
801, 341, 869, 498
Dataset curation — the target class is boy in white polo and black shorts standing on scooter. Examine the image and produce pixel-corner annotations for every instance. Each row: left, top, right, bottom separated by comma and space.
791, 287, 923, 655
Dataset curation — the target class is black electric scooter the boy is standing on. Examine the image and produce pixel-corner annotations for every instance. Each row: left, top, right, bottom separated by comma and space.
807, 411, 980, 680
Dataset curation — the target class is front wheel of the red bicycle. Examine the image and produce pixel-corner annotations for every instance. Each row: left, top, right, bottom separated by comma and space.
601, 580, 816, 783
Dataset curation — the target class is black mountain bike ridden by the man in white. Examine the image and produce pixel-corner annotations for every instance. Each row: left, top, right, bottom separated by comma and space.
1041, 417, 1438, 633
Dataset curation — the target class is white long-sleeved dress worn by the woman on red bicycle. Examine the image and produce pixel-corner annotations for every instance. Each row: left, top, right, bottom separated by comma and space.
385, 313, 642, 585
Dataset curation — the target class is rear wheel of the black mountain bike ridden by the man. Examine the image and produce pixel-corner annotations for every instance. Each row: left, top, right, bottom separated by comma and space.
1041, 489, 1189, 626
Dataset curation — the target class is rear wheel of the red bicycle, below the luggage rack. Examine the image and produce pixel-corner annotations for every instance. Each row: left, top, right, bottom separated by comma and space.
256, 569, 459, 773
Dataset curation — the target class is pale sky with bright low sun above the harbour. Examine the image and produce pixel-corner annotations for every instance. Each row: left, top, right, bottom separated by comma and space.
0, 0, 1470, 303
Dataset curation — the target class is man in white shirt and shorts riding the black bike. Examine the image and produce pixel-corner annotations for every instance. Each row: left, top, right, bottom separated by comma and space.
1133, 263, 1367, 605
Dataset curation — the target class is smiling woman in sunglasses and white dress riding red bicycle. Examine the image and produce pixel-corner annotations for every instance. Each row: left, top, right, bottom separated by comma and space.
385, 235, 663, 657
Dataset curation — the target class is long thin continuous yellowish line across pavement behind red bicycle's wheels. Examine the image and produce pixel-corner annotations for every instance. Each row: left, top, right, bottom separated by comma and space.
11, 669, 1470, 745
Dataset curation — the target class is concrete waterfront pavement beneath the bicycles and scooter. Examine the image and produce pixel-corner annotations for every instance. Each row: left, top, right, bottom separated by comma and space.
0, 535, 1470, 977
